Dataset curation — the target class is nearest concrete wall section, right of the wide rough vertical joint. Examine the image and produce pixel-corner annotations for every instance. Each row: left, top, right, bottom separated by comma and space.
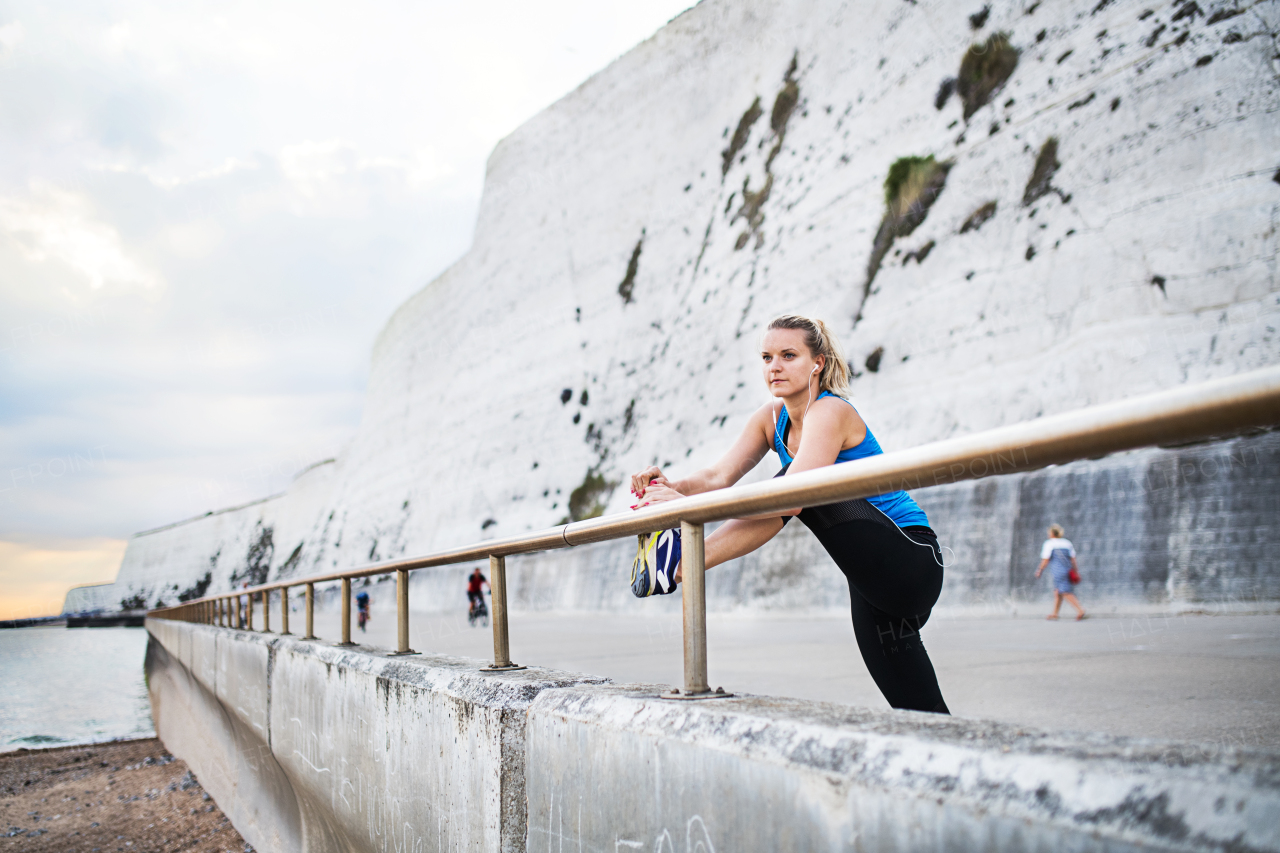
525, 685, 1280, 853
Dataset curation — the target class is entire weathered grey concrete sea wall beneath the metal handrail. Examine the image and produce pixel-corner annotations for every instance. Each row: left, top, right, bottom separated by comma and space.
147, 620, 1280, 853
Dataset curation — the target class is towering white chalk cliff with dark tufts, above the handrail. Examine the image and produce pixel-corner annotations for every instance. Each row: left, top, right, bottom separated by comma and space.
104, 0, 1280, 612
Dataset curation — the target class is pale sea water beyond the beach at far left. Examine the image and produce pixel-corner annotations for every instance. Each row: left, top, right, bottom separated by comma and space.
0, 625, 155, 752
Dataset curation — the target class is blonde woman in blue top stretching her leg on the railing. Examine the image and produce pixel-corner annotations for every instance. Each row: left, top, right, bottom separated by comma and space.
631, 315, 948, 713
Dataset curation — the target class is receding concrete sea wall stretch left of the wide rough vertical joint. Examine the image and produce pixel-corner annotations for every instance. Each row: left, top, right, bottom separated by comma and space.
146, 619, 603, 853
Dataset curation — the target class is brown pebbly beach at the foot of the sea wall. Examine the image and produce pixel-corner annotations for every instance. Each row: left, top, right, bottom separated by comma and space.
0, 738, 252, 853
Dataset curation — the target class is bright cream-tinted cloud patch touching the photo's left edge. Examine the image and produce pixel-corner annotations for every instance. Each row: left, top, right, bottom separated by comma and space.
0, 183, 160, 289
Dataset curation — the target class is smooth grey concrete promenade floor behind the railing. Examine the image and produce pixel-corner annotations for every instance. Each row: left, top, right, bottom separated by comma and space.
309, 604, 1280, 749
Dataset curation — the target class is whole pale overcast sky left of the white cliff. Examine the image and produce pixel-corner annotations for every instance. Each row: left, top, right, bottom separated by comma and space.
0, 0, 690, 619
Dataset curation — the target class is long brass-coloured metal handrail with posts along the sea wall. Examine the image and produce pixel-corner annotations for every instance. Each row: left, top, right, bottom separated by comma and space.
151, 368, 1280, 697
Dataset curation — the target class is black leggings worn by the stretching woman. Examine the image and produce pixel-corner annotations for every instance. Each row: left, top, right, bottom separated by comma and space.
783, 469, 950, 713
